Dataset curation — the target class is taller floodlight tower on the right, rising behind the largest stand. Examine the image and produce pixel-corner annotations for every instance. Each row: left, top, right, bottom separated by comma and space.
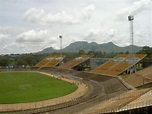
128, 15, 134, 55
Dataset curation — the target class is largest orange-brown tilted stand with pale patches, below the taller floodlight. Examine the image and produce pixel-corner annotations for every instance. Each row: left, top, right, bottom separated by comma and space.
91, 54, 146, 76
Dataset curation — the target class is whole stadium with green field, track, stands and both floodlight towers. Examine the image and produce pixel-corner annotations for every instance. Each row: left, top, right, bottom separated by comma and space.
0, 16, 152, 114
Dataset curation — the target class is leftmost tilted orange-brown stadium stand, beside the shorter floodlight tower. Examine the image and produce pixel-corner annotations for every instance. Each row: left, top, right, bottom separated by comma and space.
34, 55, 65, 68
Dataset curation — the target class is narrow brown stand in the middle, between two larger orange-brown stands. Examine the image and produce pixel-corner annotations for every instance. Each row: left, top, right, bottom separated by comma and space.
58, 55, 93, 69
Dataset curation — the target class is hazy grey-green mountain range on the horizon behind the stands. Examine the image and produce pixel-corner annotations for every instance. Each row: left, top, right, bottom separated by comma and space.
38, 41, 142, 53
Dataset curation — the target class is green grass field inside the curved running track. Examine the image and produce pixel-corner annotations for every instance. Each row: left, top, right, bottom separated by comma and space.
0, 72, 77, 104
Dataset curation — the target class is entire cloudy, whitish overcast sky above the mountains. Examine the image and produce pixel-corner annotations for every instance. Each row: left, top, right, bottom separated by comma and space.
0, 0, 152, 54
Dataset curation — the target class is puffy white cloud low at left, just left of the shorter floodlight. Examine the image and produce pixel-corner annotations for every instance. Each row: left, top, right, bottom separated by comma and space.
14, 29, 59, 52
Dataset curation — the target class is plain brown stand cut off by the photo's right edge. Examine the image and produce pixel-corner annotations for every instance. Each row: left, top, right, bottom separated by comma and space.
124, 66, 152, 87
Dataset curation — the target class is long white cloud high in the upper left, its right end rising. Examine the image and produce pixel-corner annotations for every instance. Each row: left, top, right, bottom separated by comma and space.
23, 5, 95, 26
